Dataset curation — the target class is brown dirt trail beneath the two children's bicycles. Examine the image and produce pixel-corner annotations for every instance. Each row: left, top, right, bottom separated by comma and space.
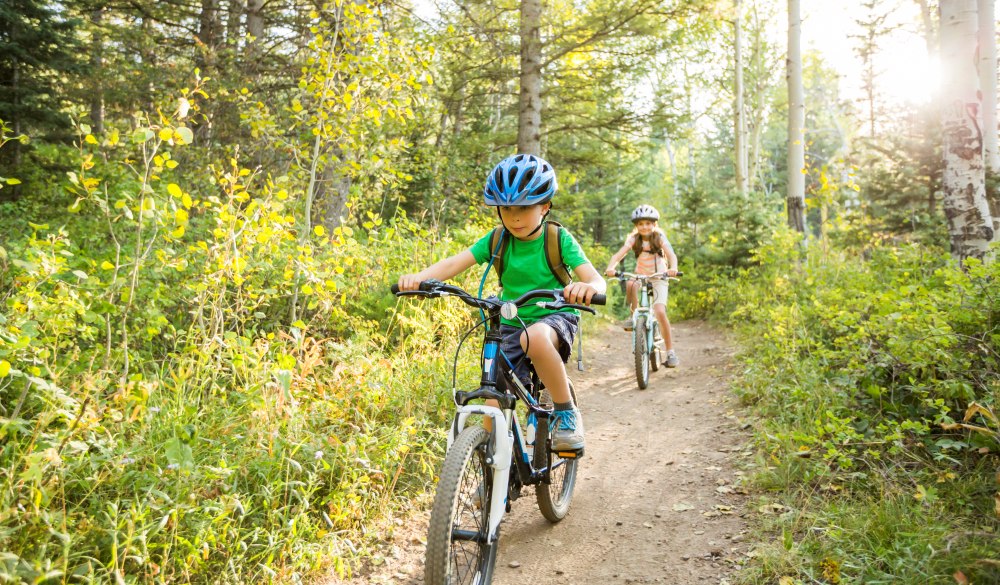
318, 321, 750, 585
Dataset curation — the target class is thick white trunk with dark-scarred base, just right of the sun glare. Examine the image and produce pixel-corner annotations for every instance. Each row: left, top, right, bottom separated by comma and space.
940, 0, 993, 260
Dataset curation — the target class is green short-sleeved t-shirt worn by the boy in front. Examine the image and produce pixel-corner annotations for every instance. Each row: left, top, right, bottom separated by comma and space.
469, 224, 590, 325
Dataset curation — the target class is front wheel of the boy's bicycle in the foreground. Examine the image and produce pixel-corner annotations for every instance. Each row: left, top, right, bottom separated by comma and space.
424, 426, 499, 585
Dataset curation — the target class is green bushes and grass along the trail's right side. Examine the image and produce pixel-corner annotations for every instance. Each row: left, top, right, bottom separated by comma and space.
684, 232, 1000, 583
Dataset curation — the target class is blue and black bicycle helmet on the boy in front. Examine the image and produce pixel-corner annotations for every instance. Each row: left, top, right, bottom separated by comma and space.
483, 154, 559, 206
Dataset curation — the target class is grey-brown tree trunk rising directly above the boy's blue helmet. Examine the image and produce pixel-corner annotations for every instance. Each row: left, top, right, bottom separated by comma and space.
517, 0, 542, 155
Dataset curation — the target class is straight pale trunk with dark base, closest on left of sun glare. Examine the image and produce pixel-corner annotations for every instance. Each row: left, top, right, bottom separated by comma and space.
787, 0, 806, 235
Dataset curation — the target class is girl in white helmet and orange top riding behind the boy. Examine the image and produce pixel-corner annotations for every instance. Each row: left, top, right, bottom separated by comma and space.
604, 205, 680, 368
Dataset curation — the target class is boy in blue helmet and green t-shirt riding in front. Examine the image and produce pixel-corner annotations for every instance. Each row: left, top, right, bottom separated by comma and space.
398, 154, 607, 451
